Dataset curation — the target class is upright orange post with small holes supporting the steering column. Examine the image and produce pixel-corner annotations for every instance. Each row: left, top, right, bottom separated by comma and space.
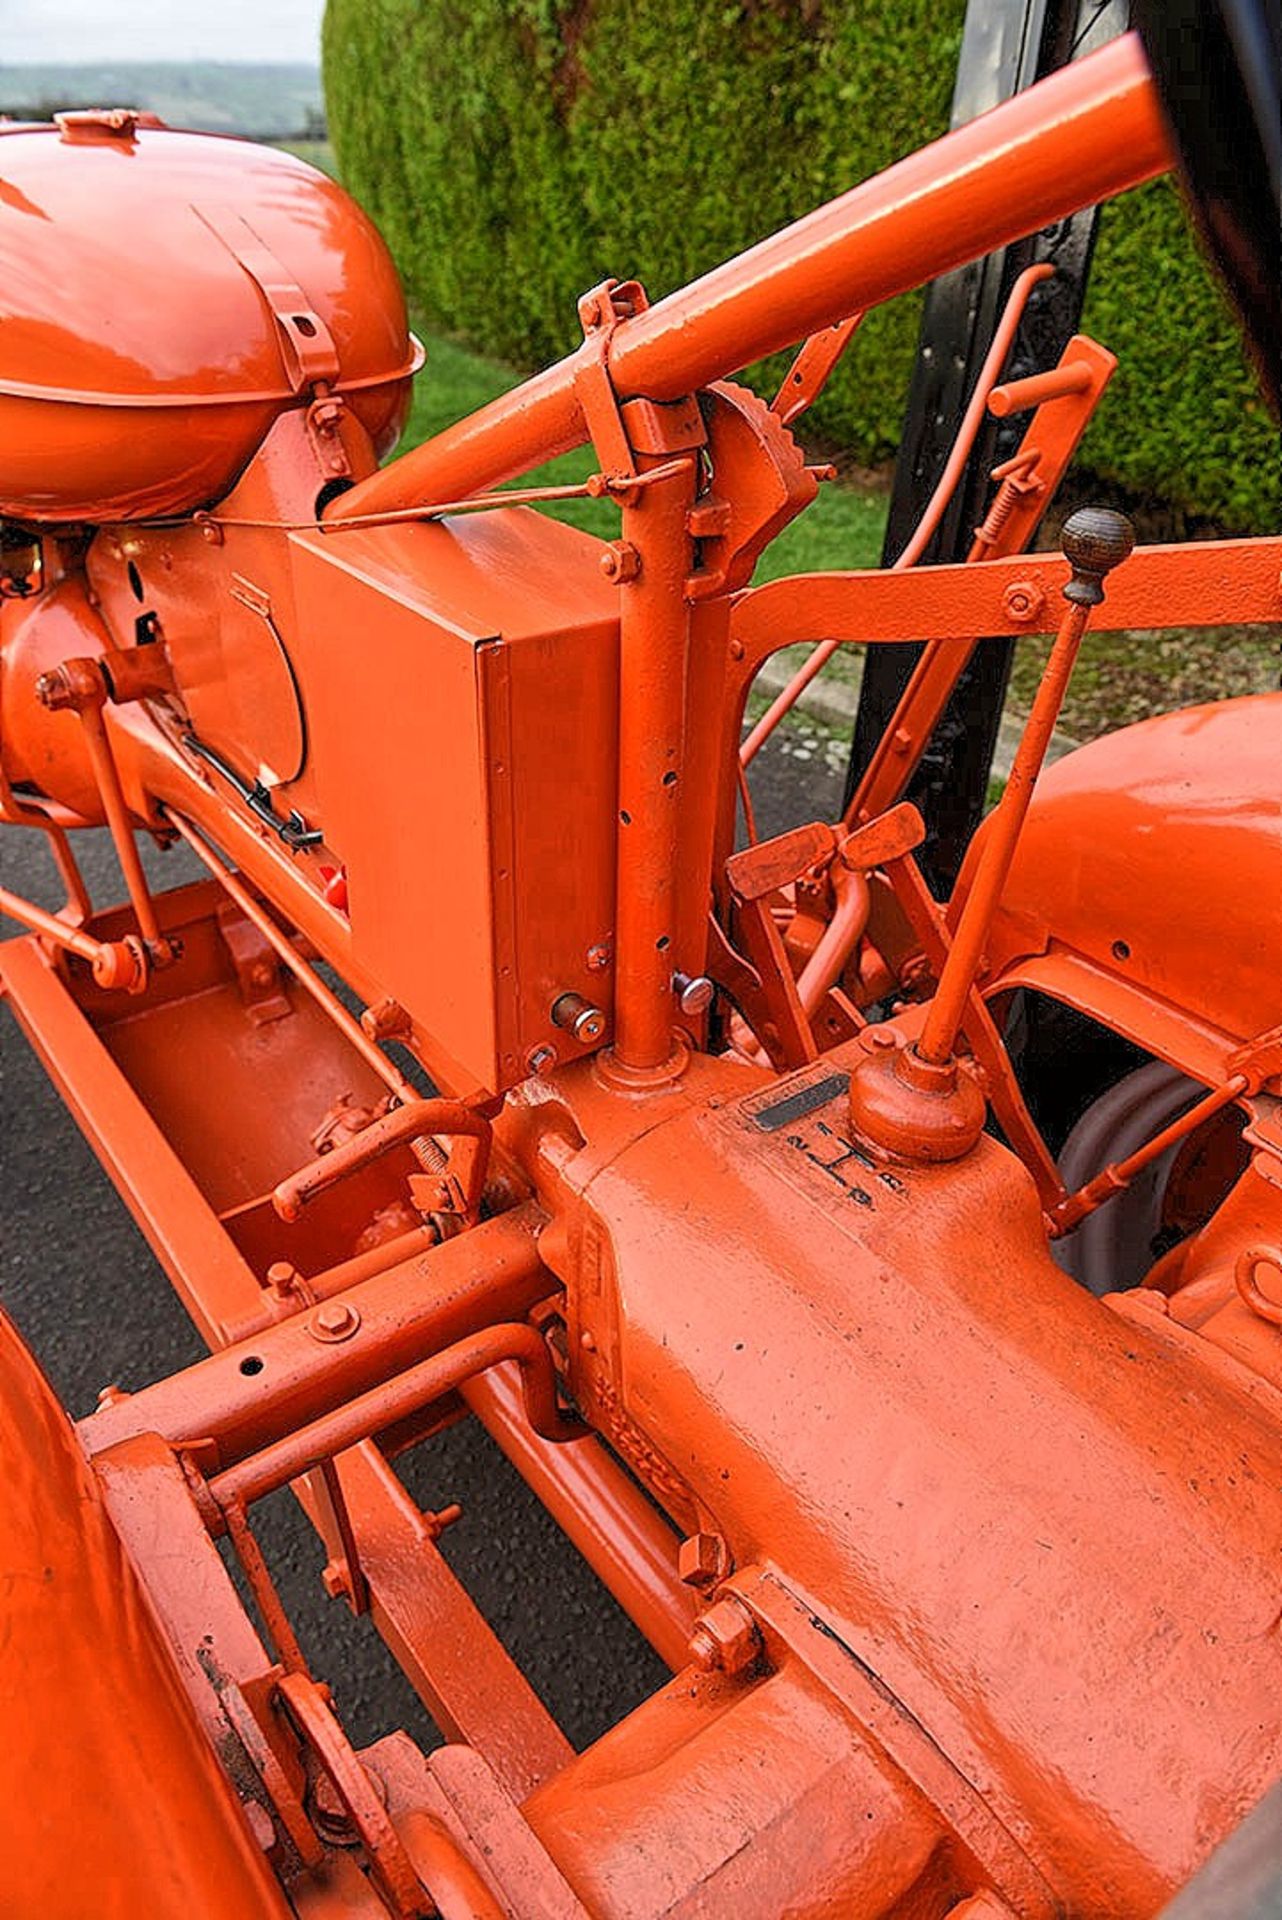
614, 459, 695, 1073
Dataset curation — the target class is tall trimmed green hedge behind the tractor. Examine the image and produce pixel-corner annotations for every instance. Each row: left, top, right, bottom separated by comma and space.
324, 0, 1282, 532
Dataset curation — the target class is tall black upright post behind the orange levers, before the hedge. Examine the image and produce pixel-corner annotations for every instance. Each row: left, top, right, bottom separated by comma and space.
846, 0, 1128, 891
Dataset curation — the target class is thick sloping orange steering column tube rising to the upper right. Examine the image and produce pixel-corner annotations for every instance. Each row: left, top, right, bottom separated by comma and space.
326, 35, 1171, 520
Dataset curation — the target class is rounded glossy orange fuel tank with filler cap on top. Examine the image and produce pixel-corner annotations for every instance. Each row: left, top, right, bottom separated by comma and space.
0, 109, 416, 524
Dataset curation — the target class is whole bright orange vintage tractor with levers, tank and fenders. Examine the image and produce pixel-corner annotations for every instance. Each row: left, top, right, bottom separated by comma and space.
0, 18, 1282, 1920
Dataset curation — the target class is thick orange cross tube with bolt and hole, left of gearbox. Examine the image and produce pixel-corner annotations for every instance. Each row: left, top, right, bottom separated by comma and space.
81, 1206, 555, 1465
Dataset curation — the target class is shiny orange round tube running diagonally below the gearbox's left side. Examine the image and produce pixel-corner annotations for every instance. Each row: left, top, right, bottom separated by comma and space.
463, 1365, 697, 1672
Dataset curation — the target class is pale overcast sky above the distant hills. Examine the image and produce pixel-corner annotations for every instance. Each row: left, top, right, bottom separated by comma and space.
0, 0, 324, 67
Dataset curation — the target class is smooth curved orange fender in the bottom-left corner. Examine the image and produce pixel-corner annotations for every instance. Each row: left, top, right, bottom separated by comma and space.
0, 1317, 288, 1920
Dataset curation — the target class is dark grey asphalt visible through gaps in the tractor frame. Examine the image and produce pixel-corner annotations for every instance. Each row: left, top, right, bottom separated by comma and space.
0, 726, 841, 1747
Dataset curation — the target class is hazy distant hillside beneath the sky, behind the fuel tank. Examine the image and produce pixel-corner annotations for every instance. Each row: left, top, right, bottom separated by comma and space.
0, 60, 324, 140
